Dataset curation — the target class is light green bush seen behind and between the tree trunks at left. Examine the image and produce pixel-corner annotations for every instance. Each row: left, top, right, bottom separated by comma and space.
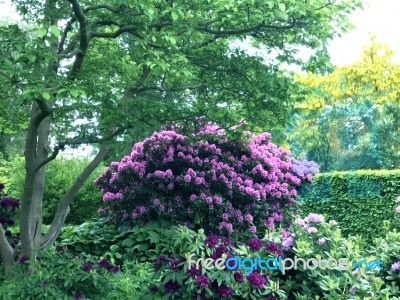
6, 157, 104, 224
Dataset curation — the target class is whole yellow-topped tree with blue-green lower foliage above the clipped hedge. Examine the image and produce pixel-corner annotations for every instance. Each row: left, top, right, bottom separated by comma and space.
291, 36, 400, 170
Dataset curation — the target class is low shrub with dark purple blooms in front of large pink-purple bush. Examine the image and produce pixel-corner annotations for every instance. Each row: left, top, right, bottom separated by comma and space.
143, 227, 289, 300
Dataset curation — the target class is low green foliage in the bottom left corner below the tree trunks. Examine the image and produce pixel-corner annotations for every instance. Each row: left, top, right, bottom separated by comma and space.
0, 247, 150, 300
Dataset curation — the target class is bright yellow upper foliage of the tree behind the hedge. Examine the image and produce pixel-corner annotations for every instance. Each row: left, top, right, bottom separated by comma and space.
297, 36, 400, 110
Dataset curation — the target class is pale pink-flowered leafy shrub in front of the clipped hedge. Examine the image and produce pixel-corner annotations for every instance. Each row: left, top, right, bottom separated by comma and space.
289, 214, 400, 300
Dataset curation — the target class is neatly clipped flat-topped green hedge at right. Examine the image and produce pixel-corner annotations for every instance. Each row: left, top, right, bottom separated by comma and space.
299, 170, 400, 241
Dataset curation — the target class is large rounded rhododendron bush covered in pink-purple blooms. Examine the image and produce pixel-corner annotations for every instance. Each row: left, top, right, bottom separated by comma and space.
95, 124, 316, 235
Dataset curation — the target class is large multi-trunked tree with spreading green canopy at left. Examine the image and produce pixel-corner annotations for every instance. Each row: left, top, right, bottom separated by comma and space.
0, 0, 360, 272
